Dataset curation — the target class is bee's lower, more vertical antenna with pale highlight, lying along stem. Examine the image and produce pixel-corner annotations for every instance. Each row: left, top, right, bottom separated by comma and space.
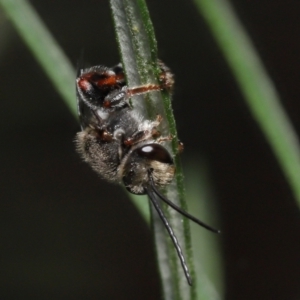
146, 187, 192, 285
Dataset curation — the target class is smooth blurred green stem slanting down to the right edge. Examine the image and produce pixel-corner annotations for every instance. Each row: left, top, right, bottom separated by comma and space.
194, 0, 300, 206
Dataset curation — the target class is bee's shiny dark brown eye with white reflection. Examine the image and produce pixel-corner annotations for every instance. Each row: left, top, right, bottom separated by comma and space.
136, 144, 173, 164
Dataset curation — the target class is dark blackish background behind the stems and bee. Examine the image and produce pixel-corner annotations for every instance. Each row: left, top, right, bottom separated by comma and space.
0, 0, 300, 300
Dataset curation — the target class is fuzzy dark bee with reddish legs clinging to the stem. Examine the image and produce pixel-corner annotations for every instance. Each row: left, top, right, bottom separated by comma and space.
75, 62, 219, 285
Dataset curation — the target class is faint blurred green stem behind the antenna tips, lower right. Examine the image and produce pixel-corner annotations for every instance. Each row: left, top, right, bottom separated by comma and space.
184, 157, 225, 300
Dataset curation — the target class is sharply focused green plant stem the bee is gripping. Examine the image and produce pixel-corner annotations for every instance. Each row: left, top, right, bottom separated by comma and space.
110, 0, 196, 300
